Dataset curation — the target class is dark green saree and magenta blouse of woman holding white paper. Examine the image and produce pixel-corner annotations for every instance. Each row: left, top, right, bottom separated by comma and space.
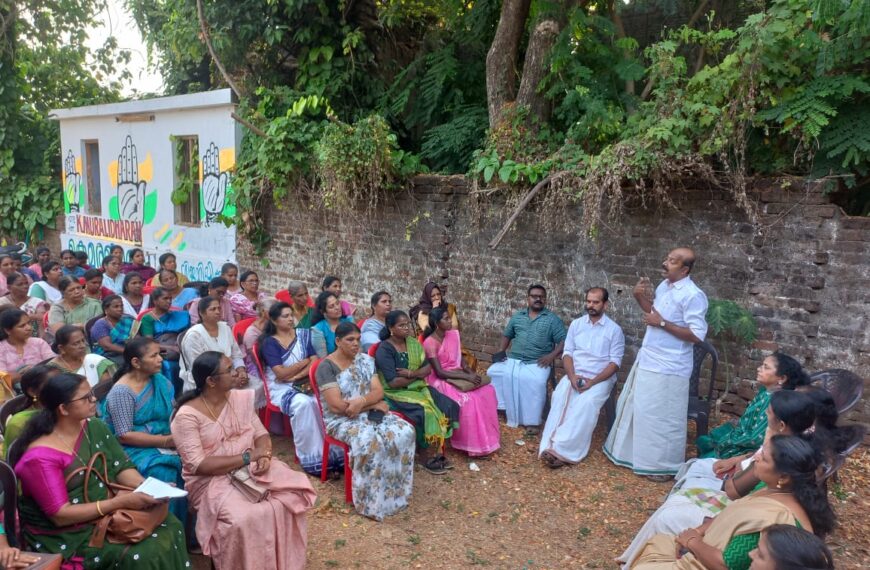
15, 419, 190, 570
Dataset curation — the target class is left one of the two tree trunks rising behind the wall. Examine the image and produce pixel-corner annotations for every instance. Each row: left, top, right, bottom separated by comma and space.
486, 0, 532, 128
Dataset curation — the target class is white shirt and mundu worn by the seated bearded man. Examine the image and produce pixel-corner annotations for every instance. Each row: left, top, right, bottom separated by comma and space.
538, 315, 625, 463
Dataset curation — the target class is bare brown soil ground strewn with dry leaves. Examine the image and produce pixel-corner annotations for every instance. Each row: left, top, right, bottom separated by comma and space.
195, 414, 870, 569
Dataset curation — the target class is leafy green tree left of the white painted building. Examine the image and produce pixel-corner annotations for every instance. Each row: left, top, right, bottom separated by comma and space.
0, 0, 129, 240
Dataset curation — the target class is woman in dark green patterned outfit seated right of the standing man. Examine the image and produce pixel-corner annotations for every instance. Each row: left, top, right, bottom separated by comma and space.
695, 352, 810, 459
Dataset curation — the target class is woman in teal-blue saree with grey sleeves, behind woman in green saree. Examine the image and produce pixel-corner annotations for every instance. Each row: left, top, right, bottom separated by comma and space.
100, 337, 187, 521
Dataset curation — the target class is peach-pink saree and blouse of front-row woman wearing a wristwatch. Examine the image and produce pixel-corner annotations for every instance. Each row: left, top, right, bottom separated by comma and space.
172, 390, 316, 570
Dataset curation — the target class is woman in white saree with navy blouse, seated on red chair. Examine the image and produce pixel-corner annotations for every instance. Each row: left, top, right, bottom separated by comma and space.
259, 303, 344, 475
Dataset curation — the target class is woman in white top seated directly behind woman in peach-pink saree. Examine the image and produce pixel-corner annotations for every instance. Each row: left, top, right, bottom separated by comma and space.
181, 297, 266, 409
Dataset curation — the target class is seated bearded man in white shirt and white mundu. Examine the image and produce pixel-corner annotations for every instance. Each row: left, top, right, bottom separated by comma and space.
538, 287, 625, 469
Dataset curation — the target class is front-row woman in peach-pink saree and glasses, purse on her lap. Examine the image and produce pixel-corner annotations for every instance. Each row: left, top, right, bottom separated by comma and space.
172, 351, 316, 570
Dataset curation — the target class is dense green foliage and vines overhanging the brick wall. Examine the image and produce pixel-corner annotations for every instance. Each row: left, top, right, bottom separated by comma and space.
128, 0, 870, 246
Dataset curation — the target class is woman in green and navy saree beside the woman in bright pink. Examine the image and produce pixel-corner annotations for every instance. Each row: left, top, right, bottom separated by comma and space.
375, 311, 459, 475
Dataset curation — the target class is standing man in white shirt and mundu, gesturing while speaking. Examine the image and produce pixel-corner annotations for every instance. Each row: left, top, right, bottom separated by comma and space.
604, 247, 707, 481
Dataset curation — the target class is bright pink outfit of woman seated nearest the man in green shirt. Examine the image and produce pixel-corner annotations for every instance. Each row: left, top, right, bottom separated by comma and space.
423, 329, 501, 455
